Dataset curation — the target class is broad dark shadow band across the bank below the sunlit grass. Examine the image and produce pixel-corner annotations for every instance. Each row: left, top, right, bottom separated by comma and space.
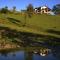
0, 26, 60, 46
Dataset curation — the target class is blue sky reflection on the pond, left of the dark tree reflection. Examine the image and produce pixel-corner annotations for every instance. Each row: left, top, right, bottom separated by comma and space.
0, 51, 24, 60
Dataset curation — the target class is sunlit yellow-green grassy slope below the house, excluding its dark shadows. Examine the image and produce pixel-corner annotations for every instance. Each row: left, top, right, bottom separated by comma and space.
0, 14, 60, 37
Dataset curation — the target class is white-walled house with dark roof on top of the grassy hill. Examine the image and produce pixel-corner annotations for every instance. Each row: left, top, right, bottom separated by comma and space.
34, 6, 51, 14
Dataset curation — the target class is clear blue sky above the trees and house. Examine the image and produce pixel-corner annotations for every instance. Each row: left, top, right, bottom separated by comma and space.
0, 0, 60, 11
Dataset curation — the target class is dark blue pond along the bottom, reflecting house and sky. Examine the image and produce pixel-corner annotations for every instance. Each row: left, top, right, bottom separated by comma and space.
0, 47, 60, 60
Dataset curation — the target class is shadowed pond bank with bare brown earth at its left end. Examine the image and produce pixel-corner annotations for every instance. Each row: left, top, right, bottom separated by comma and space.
0, 27, 60, 49
